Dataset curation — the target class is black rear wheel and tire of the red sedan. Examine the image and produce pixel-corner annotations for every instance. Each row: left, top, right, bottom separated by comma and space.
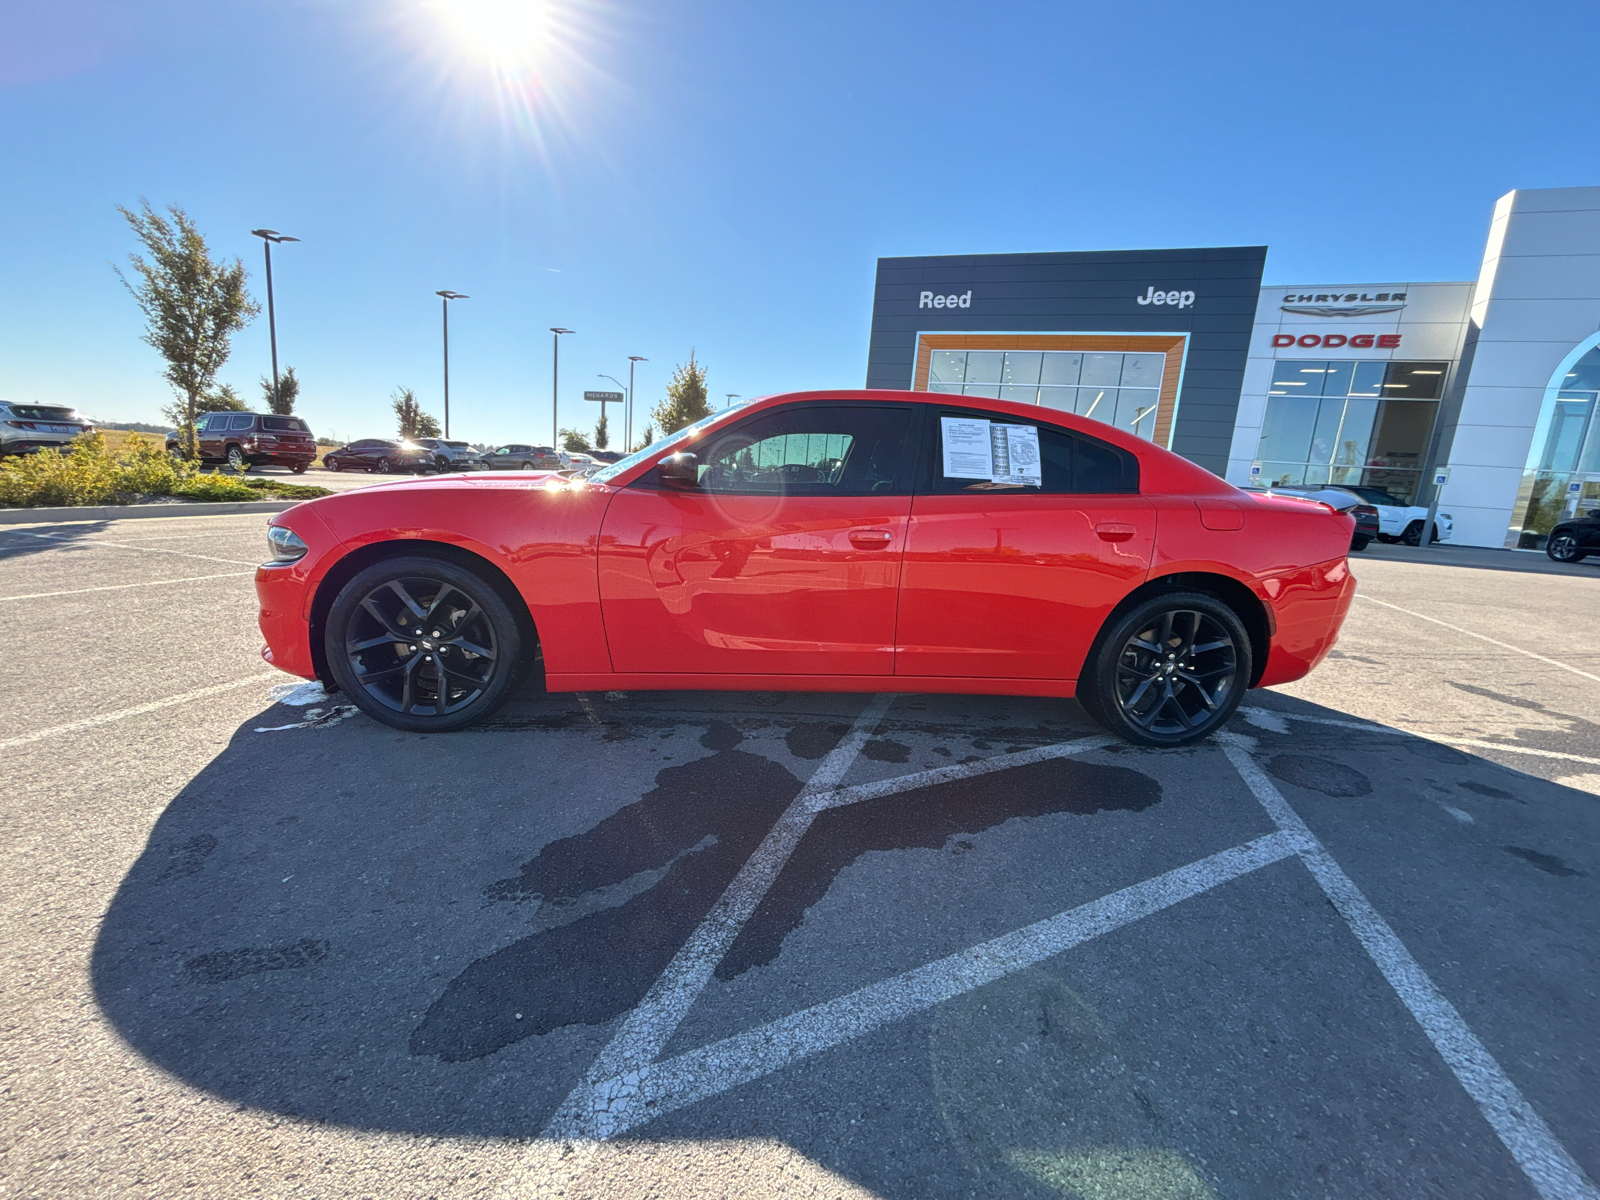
1078, 592, 1253, 747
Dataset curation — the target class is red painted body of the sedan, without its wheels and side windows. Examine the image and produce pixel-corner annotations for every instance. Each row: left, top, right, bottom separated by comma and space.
256, 390, 1355, 696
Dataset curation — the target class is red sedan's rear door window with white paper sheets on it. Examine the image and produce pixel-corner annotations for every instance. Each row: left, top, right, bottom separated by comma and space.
923, 408, 1139, 496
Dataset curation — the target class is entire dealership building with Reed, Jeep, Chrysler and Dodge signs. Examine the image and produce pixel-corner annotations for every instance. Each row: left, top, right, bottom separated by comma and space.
867, 187, 1600, 549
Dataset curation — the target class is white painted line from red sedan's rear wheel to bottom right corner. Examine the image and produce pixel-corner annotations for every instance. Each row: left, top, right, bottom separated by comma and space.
1218, 733, 1600, 1200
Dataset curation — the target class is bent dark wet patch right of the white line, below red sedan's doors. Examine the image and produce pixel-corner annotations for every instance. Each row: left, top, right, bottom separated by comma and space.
717, 758, 1162, 979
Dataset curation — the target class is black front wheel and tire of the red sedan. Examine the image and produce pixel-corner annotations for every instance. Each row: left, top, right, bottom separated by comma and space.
323, 555, 523, 733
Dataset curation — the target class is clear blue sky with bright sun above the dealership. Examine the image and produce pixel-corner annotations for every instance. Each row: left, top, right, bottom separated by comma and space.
0, 0, 1600, 442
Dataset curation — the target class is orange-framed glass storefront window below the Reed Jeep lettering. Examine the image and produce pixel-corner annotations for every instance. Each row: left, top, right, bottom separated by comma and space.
928, 350, 1166, 440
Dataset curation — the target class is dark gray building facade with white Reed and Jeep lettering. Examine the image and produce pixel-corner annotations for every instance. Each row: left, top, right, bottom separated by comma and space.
867, 246, 1267, 475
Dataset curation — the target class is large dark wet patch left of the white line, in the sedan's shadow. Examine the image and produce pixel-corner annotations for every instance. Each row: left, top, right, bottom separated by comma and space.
411, 722, 819, 1062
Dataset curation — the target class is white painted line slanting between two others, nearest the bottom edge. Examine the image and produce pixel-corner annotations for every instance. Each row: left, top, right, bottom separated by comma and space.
546, 832, 1299, 1138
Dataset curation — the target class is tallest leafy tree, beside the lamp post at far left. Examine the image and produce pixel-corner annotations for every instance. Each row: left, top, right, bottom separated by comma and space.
112, 198, 261, 458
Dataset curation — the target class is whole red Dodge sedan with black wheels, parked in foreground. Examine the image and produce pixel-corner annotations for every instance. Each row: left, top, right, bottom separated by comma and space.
256, 390, 1355, 746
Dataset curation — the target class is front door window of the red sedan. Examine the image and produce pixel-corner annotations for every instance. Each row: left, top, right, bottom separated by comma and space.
699, 405, 912, 496
